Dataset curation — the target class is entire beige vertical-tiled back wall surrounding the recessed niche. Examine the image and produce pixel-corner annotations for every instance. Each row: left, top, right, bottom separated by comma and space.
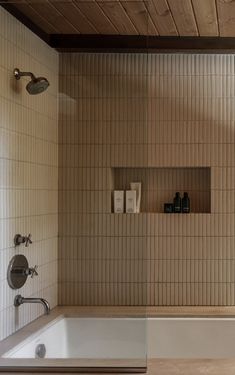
59, 54, 235, 305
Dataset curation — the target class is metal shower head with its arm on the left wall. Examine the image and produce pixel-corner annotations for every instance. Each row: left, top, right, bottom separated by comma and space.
14, 68, 50, 95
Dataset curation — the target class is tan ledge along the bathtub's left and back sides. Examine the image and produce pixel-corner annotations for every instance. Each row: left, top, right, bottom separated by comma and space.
0, 306, 235, 358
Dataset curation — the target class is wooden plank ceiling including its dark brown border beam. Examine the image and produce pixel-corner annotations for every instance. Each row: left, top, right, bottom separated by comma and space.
0, 0, 235, 53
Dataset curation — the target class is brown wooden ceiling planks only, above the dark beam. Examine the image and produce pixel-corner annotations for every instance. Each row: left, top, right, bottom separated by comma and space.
0, 0, 235, 37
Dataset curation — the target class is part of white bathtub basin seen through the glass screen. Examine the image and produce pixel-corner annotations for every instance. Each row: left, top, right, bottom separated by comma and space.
3, 317, 146, 360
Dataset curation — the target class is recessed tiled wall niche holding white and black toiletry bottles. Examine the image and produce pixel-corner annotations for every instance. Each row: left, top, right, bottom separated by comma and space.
112, 167, 211, 215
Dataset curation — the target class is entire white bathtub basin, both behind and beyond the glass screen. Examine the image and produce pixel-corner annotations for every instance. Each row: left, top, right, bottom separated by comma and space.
2, 317, 235, 361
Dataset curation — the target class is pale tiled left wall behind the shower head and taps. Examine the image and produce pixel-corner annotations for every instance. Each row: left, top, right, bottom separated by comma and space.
0, 7, 58, 340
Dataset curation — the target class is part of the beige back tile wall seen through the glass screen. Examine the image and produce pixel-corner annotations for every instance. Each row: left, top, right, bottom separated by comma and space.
59, 54, 148, 305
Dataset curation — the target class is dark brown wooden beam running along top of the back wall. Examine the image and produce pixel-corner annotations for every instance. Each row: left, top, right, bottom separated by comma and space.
50, 34, 235, 53
